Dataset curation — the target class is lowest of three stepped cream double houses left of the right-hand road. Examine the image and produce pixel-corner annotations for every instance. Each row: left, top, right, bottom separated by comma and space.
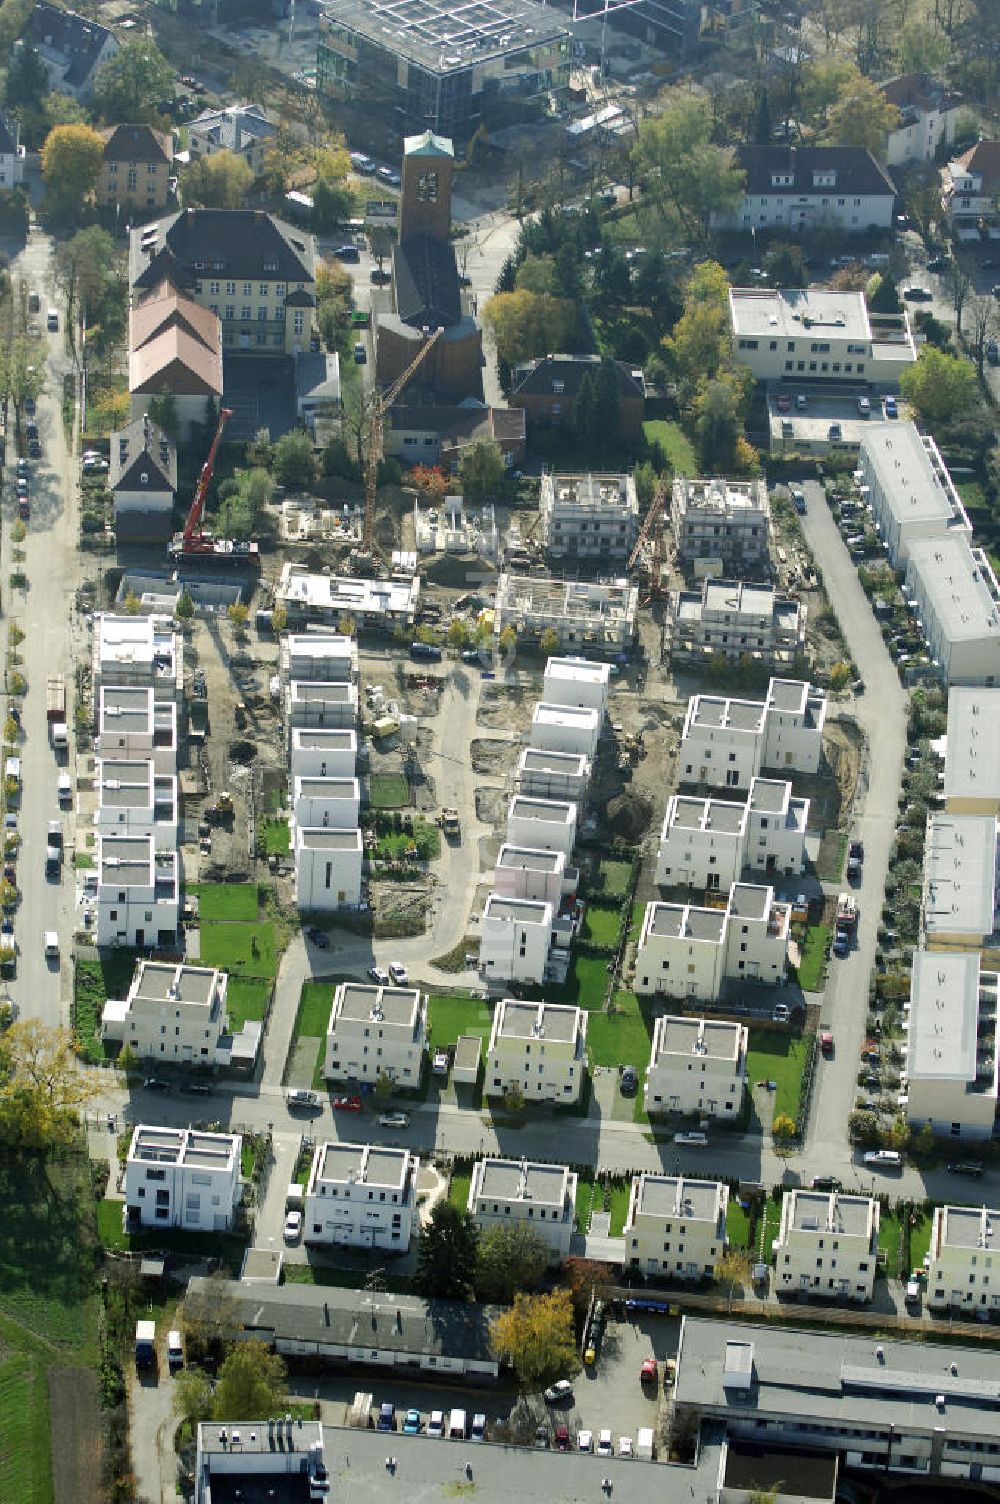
635, 883, 791, 1002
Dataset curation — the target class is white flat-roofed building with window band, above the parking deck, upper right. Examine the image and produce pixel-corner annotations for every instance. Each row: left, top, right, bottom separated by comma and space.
729, 287, 917, 390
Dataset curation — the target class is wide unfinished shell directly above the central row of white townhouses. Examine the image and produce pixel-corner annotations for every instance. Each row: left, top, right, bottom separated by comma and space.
493, 570, 639, 654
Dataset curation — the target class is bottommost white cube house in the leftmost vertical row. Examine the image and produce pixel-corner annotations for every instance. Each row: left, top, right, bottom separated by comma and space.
95, 832, 180, 951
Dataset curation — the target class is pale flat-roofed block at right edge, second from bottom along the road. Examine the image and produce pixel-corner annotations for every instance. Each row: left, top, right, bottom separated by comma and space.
920, 812, 1000, 951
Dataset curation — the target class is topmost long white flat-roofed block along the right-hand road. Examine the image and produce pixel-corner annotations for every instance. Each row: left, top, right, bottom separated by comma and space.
857, 423, 973, 569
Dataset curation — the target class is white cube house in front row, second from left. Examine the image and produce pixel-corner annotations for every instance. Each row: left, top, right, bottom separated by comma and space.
302, 1143, 420, 1253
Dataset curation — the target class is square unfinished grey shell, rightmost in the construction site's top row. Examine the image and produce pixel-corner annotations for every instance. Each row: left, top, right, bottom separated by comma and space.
671, 475, 771, 575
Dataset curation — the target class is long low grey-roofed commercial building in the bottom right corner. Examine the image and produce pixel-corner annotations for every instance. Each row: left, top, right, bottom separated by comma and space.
674, 1316, 1000, 1481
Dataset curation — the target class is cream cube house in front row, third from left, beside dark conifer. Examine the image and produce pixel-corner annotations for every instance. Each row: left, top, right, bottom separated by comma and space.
468, 1160, 576, 1263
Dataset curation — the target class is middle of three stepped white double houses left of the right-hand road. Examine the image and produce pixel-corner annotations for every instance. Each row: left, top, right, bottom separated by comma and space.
656, 778, 809, 890
